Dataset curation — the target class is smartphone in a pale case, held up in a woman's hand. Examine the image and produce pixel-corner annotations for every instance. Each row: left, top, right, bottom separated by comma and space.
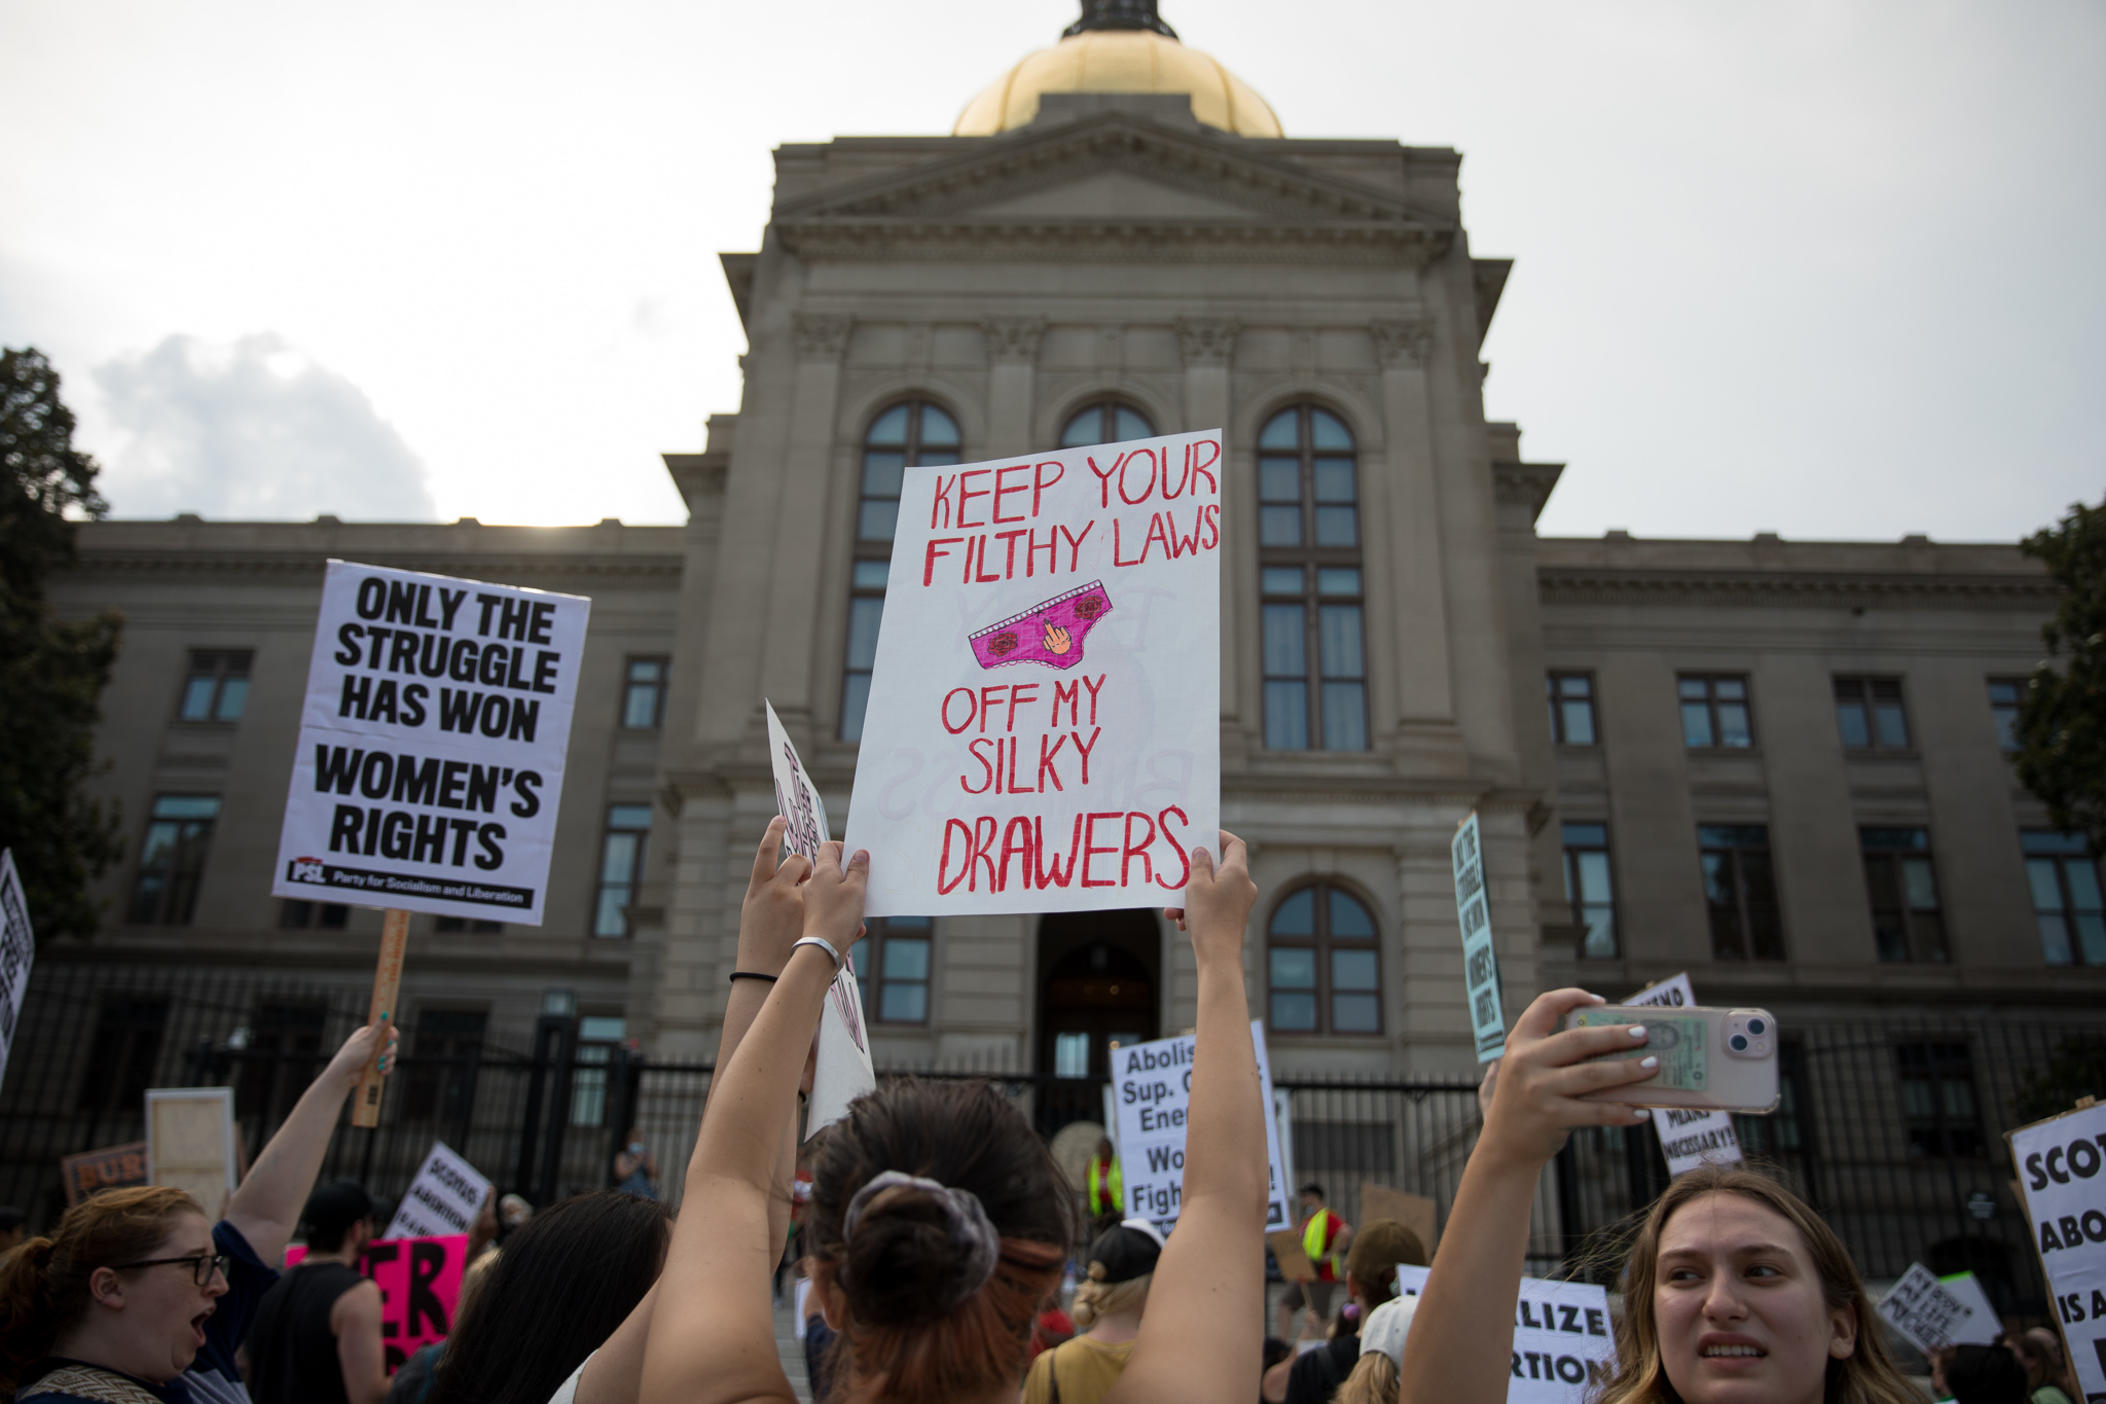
1565, 1004, 1777, 1114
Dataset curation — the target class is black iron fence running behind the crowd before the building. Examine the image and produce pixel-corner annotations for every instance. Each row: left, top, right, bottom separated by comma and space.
0, 958, 2106, 1316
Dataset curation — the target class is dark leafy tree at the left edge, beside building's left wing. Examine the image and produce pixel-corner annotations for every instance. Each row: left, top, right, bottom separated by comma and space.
0, 347, 122, 939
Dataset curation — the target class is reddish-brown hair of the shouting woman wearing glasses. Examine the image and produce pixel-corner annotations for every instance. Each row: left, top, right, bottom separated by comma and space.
0, 1185, 204, 1393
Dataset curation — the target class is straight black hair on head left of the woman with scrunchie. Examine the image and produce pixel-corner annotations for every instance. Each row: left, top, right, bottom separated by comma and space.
432, 1189, 672, 1404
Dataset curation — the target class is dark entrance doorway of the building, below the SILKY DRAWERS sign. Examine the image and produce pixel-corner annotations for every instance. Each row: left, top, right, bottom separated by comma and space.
1038, 909, 1163, 1135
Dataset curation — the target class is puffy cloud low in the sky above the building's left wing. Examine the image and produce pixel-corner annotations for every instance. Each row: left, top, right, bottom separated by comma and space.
95, 333, 436, 522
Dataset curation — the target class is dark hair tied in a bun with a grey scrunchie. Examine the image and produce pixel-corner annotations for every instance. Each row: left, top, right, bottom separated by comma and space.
804, 1078, 1074, 1404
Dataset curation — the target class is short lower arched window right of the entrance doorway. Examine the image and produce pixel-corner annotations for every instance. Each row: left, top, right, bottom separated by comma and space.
1266, 882, 1382, 1034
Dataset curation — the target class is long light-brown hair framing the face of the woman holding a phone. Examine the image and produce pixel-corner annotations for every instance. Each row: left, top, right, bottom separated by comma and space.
1592, 1166, 1923, 1404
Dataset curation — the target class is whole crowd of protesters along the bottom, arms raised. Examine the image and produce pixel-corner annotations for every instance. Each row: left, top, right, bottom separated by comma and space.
0, 819, 2074, 1404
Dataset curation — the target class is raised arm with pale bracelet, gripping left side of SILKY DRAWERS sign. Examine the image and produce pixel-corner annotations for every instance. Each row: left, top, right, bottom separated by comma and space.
638, 844, 870, 1404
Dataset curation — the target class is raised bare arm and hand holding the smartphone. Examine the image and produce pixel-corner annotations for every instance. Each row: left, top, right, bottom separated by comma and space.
1398, 989, 1657, 1404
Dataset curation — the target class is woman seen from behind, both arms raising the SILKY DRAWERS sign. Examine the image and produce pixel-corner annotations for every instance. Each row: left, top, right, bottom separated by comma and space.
640, 834, 1266, 1404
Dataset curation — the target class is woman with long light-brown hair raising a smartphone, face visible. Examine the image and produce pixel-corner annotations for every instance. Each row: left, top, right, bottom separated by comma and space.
1400, 989, 1923, 1404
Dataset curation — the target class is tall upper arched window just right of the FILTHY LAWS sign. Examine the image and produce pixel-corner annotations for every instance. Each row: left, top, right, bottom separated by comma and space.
1257, 404, 1367, 751
